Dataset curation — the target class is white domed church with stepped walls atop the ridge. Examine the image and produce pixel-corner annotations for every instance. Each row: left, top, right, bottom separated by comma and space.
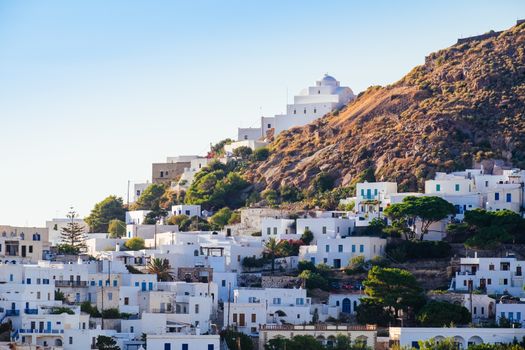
237, 74, 355, 144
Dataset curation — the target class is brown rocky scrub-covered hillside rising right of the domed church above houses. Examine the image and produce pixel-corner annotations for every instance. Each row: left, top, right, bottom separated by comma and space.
246, 24, 525, 190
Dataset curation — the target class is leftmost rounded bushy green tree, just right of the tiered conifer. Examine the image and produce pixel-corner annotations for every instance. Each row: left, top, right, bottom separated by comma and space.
84, 196, 126, 232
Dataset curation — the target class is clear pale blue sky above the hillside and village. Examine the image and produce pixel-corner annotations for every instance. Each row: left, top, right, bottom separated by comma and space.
0, 0, 525, 226
